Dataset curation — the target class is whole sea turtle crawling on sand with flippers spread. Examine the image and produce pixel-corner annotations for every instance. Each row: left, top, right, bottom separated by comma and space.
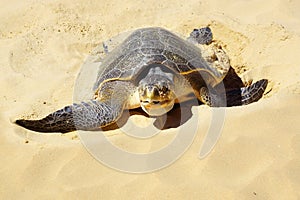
16, 27, 268, 133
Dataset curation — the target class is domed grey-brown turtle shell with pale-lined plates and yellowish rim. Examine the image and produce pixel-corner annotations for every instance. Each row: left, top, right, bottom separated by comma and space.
94, 28, 225, 90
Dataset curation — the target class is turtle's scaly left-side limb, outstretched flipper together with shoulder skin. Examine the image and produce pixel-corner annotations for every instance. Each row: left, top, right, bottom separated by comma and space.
16, 81, 132, 133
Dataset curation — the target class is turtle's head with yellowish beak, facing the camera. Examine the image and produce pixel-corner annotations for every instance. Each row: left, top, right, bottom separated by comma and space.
138, 67, 176, 116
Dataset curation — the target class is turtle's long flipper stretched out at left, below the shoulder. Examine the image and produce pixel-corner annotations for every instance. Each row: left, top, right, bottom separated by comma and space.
16, 100, 123, 133
